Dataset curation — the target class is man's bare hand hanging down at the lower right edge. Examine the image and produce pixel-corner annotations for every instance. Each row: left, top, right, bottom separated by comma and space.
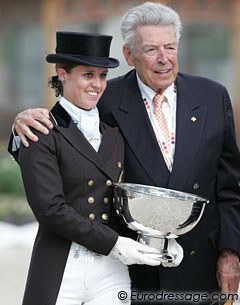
217, 249, 240, 293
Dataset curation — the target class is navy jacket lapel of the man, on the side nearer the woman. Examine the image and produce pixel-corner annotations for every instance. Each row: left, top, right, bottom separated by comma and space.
113, 71, 169, 187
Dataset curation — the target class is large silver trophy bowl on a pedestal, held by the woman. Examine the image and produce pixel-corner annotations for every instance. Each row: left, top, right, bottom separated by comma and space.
114, 183, 209, 262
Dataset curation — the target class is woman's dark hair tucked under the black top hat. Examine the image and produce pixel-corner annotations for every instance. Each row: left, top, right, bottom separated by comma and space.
48, 62, 79, 97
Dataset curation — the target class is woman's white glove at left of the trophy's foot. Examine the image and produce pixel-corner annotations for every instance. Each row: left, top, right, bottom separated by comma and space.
109, 236, 161, 266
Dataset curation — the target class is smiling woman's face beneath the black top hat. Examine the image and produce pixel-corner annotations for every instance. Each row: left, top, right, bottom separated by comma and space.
58, 65, 108, 110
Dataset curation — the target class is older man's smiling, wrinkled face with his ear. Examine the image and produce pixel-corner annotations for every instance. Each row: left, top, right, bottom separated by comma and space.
123, 25, 178, 92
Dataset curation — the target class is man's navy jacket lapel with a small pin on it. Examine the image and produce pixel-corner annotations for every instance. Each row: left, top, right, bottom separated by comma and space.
168, 75, 207, 190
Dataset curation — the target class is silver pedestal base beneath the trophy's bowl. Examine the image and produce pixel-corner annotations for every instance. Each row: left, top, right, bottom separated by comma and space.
137, 232, 177, 263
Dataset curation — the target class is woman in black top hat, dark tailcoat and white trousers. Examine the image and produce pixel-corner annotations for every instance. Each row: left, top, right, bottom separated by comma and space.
18, 32, 160, 305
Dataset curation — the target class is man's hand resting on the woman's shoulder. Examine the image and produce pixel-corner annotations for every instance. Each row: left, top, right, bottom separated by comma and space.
14, 108, 53, 147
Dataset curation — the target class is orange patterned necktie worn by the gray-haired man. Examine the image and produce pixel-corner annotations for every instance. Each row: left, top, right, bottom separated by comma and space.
153, 93, 170, 148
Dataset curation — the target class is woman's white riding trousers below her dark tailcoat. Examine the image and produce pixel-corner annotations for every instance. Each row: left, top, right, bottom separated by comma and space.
56, 242, 131, 305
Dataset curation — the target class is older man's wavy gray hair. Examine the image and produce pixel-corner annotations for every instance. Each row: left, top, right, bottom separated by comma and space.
121, 2, 182, 51
